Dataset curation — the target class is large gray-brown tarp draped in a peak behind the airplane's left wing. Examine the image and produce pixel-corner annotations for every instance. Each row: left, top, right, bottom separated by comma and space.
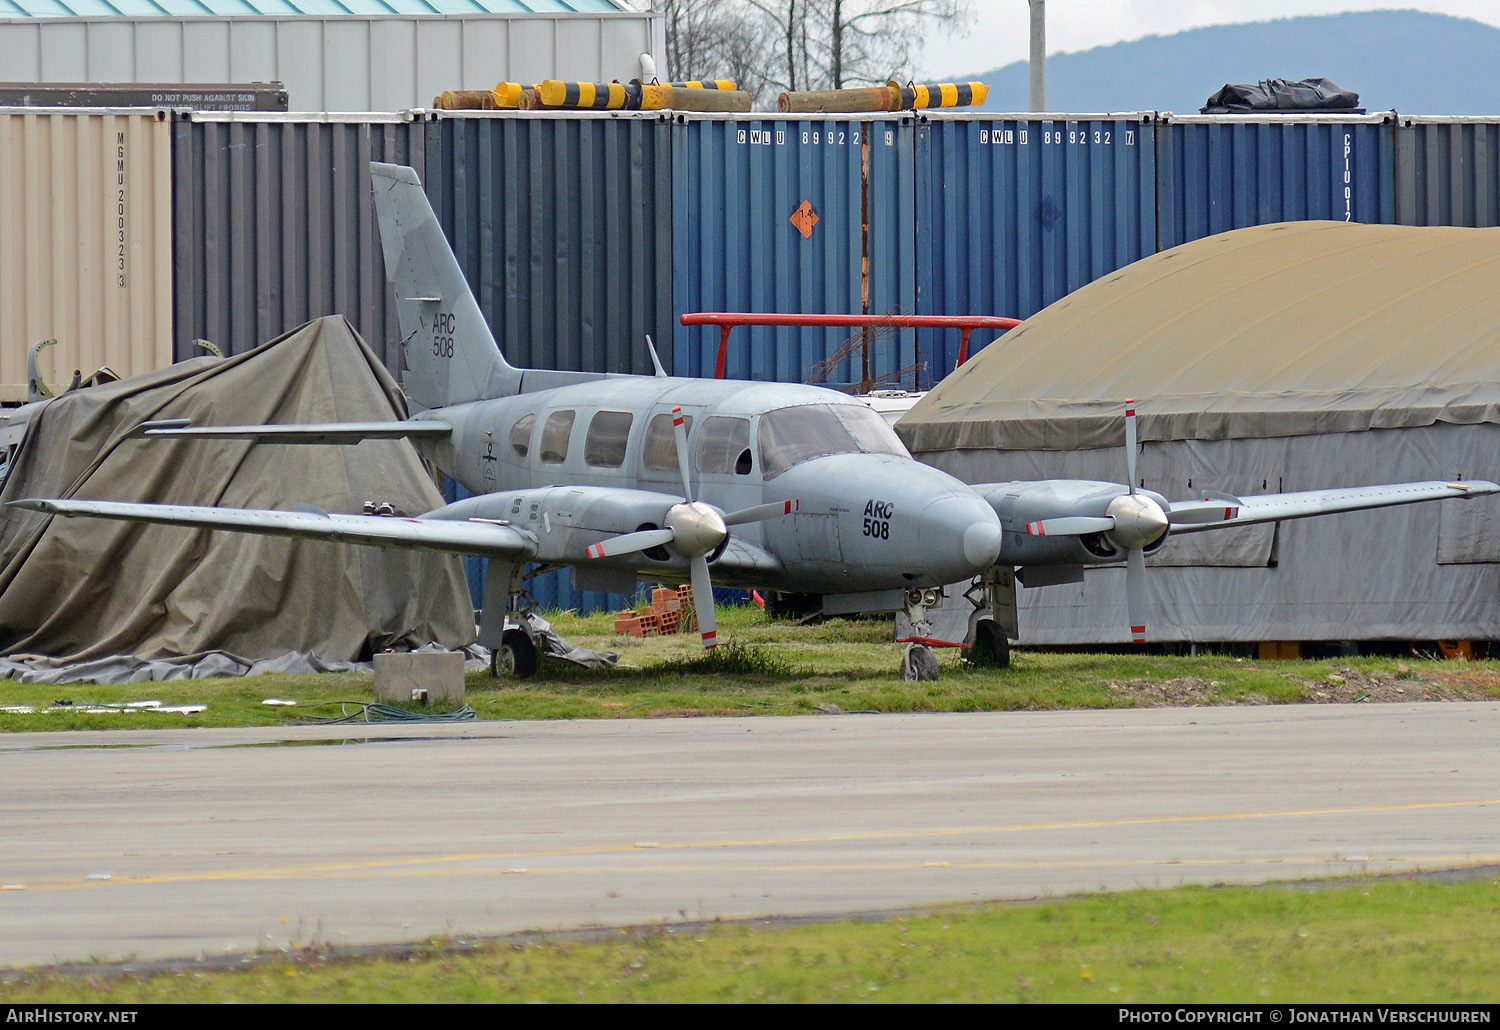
0, 316, 474, 661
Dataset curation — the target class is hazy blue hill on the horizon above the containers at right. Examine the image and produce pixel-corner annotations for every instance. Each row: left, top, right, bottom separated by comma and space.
962, 10, 1500, 115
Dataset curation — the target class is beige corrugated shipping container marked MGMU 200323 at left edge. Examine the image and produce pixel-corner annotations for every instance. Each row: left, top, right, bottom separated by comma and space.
0, 108, 173, 403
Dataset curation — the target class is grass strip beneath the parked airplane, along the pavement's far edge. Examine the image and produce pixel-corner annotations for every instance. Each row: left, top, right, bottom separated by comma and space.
0, 607, 1500, 732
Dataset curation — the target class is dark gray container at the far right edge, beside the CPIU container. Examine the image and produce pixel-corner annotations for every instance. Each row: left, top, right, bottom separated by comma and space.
1395, 118, 1500, 226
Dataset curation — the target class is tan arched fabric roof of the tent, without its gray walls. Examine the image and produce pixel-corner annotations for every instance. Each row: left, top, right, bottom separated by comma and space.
899, 222, 1500, 451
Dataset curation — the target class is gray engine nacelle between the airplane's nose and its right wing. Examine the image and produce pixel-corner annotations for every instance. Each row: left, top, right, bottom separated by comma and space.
974, 480, 1169, 565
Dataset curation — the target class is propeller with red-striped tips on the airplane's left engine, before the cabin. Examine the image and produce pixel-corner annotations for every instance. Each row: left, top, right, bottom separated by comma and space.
587, 408, 801, 648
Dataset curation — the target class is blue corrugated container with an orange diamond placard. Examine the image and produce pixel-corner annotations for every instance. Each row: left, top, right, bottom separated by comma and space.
672, 115, 917, 382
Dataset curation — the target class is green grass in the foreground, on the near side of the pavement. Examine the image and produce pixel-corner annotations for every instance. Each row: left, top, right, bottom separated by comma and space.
0, 877, 1500, 1005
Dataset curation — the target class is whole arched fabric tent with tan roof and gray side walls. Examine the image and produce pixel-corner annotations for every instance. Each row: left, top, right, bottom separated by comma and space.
897, 222, 1500, 643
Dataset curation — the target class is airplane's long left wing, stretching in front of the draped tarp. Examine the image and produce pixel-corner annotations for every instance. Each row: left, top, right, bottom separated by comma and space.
9, 499, 537, 561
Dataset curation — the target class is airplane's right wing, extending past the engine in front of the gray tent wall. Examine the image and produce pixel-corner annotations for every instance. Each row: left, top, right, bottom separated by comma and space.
1167, 480, 1500, 534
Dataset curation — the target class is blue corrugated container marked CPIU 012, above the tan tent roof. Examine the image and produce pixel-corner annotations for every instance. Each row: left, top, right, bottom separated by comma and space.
1157, 114, 1397, 250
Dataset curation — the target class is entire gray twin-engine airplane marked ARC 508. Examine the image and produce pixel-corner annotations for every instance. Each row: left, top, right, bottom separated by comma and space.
14, 163, 1500, 676
